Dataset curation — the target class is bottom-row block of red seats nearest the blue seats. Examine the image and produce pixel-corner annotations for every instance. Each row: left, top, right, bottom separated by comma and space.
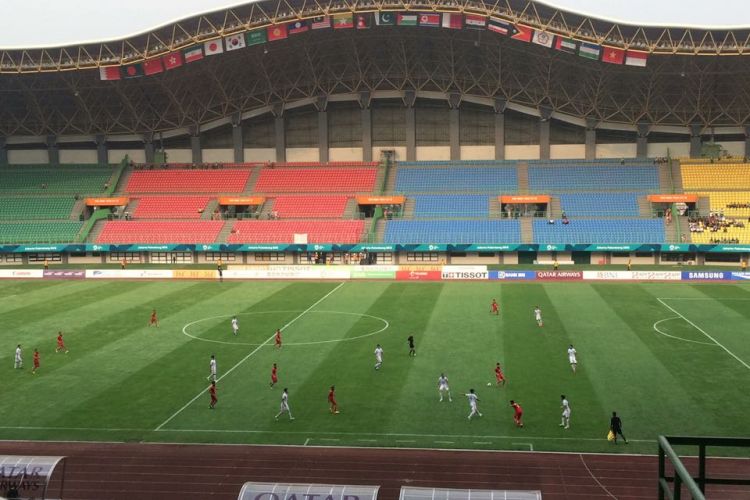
228, 220, 365, 243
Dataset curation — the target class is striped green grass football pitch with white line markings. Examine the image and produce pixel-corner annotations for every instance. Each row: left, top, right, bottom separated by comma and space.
0, 281, 750, 453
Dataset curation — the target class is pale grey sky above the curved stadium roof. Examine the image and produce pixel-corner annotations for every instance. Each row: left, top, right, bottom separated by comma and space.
0, 0, 750, 48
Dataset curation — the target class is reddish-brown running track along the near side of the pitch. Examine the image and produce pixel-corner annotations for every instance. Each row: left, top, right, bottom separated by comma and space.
0, 441, 750, 500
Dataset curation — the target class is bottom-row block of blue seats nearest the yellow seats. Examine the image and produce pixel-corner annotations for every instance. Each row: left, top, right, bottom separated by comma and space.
533, 219, 665, 244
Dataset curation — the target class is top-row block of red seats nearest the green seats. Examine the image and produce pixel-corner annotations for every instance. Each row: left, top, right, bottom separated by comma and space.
125, 169, 251, 193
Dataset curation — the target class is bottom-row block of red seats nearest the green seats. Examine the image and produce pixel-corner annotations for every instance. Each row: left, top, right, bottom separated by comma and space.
96, 220, 224, 244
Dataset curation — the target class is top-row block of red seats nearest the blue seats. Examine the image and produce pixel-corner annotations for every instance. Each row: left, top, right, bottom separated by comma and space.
254, 167, 378, 193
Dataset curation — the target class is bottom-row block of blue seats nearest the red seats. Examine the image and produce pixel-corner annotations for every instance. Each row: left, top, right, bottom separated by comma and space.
384, 220, 521, 244
